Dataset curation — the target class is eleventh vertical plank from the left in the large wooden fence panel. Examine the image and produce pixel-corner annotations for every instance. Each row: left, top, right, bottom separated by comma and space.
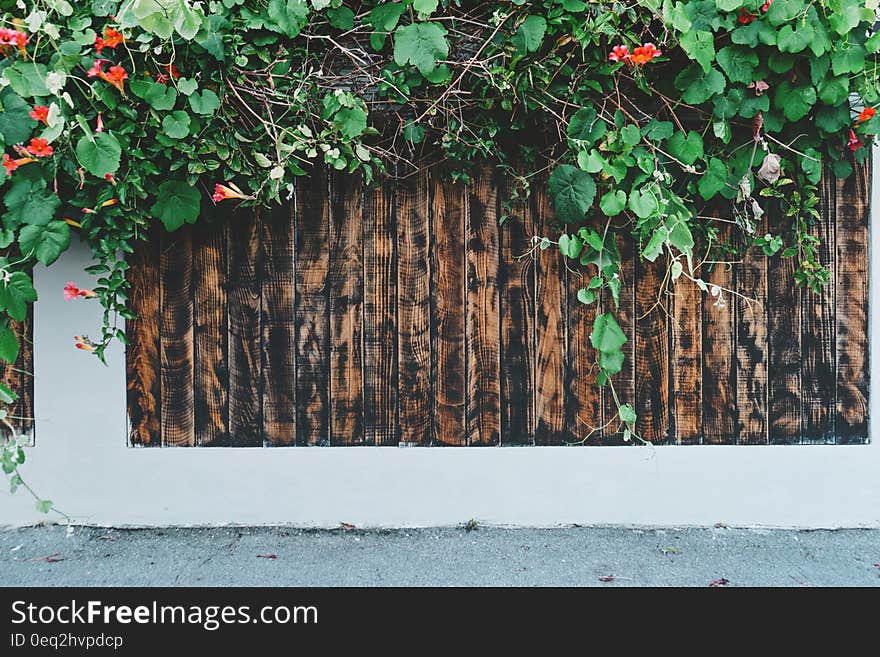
465, 165, 501, 446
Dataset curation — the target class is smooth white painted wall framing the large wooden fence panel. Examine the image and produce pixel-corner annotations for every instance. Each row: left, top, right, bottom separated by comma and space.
0, 152, 880, 527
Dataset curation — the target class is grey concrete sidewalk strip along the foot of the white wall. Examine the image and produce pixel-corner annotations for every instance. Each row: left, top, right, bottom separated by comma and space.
0, 526, 880, 586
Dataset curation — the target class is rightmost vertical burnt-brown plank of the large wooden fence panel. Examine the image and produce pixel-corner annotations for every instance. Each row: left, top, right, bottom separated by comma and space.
834, 161, 871, 444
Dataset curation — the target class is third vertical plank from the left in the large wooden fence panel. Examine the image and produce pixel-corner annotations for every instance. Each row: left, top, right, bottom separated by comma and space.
193, 218, 229, 445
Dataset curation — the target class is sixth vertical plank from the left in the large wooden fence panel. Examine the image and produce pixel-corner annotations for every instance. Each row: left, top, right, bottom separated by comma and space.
296, 168, 330, 446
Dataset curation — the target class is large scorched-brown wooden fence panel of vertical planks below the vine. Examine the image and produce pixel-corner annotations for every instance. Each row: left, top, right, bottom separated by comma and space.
120, 162, 868, 446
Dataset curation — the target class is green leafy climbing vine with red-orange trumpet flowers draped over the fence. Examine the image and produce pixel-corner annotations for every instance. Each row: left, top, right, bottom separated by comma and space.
0, 0, 880, 502
